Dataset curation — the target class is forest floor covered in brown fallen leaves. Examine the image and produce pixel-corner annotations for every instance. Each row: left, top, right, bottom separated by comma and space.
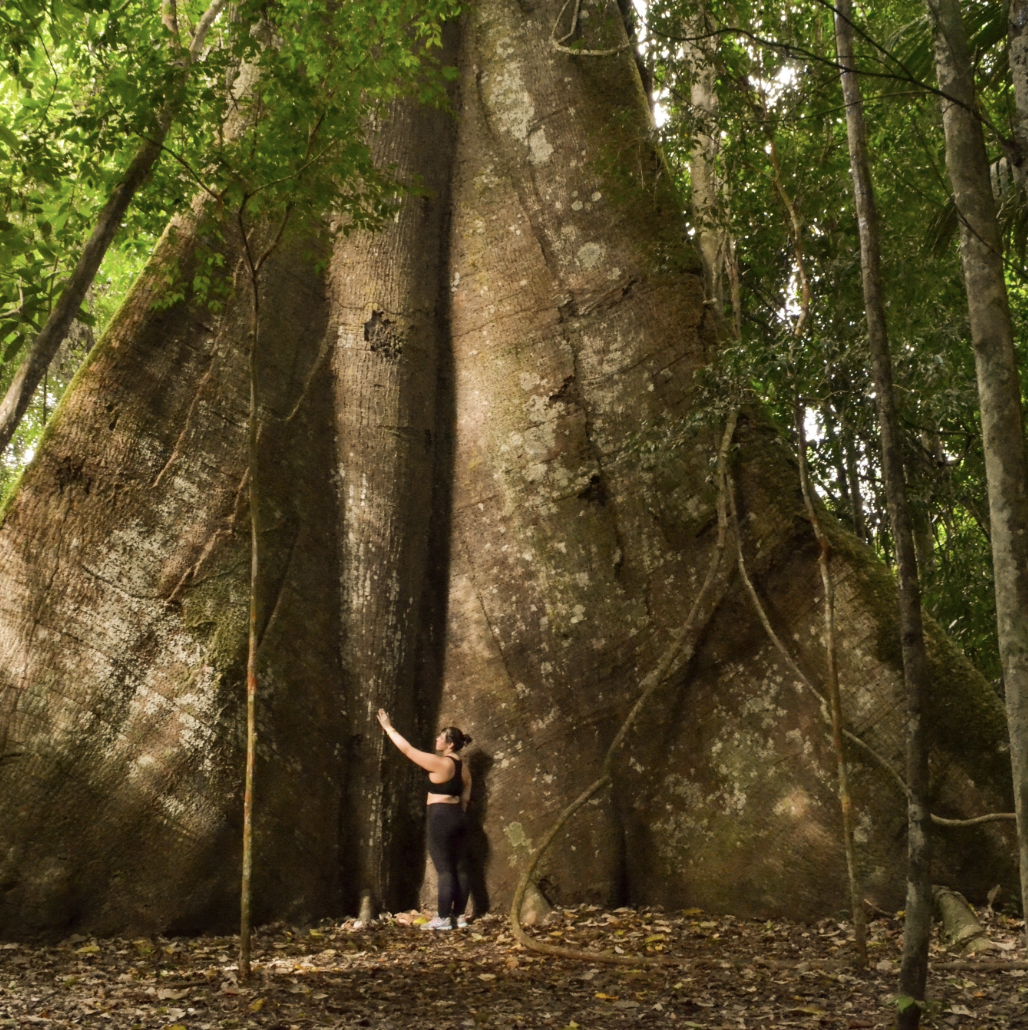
0, 906, 1028, 1030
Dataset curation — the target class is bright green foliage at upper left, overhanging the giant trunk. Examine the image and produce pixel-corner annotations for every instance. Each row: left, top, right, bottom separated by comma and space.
0, 0, 457, 500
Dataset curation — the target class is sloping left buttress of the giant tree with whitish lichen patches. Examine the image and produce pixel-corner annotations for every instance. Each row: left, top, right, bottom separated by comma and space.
0, 207, 342, 934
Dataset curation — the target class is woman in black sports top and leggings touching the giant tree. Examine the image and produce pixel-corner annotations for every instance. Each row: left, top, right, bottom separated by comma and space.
378, 709, 471, 930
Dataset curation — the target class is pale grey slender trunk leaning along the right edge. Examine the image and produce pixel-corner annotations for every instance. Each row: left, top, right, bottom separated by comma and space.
928, 0, 1028, 947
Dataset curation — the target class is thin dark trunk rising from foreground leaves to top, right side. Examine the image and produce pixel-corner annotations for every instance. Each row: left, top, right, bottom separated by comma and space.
835, 0, 932, 1013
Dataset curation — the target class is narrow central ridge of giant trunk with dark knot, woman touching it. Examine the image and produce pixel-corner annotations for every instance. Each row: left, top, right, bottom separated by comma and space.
329, 25, 457, 919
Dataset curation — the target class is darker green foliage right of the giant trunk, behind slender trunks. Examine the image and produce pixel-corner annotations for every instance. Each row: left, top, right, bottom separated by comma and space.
641, 0, 1028, 680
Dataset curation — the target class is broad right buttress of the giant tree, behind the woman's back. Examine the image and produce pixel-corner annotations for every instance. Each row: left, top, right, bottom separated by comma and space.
432, 0, 1010, 917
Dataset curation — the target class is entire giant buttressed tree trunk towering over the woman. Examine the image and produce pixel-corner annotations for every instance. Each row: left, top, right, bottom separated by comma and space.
0, 0, 1012, 933
